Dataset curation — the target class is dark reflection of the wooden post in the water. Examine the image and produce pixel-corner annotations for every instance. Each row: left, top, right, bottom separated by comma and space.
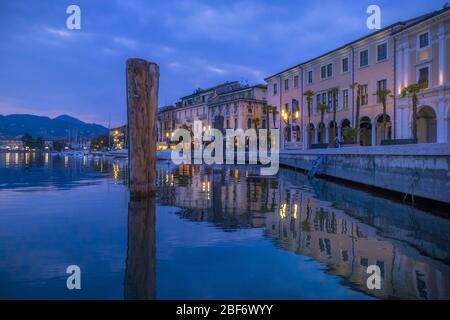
125, 197, 156, 300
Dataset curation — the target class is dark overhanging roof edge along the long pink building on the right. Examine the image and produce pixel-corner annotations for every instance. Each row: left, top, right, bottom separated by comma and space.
264, 7, 450, 81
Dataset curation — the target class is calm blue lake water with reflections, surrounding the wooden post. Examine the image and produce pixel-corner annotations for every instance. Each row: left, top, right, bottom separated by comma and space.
0, 153, 450, 299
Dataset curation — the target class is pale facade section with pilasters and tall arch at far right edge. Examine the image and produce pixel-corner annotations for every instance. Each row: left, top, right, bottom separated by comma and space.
393, 7, 450, 143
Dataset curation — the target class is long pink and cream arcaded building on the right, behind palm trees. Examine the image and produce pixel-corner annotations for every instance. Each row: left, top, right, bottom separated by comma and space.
266, 7, 450, 149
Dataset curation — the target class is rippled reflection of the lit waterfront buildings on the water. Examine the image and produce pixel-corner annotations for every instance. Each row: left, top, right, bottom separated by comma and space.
159, 162, 450, 299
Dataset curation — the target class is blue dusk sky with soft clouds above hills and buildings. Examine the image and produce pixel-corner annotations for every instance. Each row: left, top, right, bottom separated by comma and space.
0, 0, 445, 125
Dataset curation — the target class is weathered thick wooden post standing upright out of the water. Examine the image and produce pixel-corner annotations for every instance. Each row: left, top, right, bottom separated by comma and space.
126, 59, 159, 198
